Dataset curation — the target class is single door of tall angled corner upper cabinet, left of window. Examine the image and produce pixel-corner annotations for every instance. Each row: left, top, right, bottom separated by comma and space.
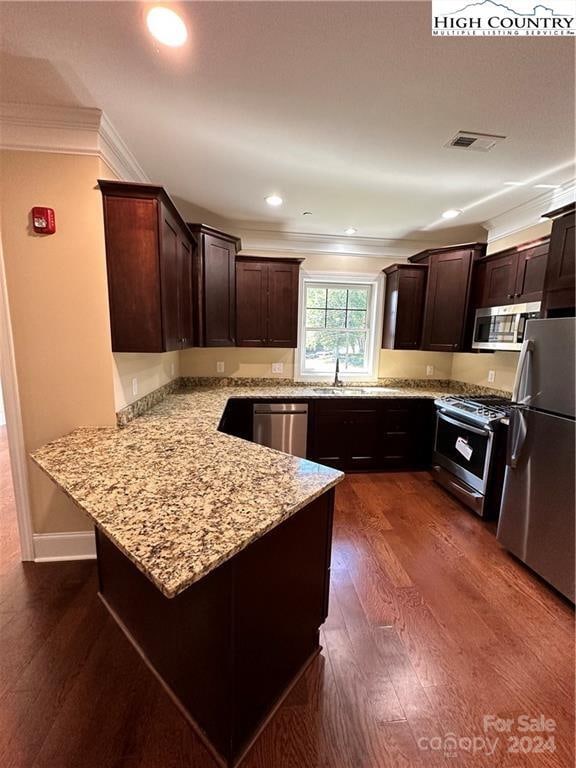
202, 235, 236, 347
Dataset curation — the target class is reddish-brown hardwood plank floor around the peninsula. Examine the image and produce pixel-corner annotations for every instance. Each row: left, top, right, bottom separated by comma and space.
0, 424, 574, 768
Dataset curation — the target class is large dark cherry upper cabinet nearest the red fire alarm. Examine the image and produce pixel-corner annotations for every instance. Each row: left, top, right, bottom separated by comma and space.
98, 181, 193, 352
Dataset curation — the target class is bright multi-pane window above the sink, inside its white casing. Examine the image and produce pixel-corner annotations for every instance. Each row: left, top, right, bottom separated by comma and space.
299, 276, 377, 378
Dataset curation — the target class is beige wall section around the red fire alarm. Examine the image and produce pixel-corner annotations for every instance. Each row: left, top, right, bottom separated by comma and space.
0, 151, 115, 532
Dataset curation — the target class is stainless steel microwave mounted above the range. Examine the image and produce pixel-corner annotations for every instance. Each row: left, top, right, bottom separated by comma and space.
472, 301, 541, 352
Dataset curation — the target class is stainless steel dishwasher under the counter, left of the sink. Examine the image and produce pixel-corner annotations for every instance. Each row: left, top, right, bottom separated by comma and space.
252, 403, 308, 459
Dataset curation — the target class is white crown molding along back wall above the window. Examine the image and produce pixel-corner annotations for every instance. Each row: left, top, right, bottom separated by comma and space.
231, 228, 460, 259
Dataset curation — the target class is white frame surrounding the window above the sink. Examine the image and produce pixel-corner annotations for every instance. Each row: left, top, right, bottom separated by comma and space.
295, 269, 384, 382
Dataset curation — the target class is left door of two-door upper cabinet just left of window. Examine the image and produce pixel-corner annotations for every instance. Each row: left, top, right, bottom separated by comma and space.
236, 260, 268, 347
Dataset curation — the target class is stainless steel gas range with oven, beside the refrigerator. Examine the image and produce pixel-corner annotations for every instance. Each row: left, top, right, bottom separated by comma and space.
433, 396, 511, 517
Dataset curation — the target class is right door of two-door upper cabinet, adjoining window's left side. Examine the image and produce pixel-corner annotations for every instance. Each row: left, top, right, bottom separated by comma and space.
266, 262, 299, 347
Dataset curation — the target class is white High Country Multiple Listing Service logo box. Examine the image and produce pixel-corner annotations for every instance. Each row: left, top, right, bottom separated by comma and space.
432, 0, 576, 37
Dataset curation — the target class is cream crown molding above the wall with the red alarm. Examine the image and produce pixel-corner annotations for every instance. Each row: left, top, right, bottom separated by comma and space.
0, 103, 149, 182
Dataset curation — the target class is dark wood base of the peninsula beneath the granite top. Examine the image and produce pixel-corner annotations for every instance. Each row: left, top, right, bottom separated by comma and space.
96, 489, 334, 766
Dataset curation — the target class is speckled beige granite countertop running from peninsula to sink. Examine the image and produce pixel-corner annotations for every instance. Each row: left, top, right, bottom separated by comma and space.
32, 386, 462, 597
